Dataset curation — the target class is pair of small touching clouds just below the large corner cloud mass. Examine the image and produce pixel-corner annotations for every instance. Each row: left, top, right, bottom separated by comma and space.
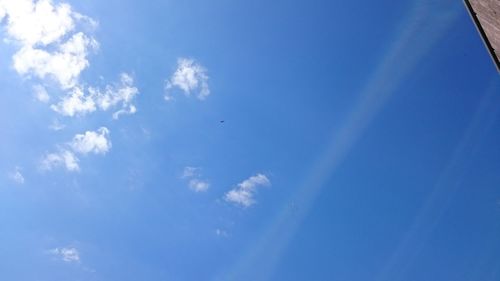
40, 127, 111, 172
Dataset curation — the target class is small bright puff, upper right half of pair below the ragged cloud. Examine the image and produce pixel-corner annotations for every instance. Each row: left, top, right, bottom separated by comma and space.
70, 127, 111, 155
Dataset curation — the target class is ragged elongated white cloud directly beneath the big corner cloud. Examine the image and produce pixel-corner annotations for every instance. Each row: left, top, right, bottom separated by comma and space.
51, 73, 139, 119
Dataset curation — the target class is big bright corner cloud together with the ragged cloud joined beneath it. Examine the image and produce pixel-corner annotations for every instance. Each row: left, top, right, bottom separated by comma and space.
0, 0, 139, 119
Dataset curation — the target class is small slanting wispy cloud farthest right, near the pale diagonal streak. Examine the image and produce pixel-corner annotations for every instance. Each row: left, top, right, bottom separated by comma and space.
224, 174, 271, 207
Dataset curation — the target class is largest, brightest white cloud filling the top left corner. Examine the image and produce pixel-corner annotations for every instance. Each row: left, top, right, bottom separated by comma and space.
0, 0, 98, 89
